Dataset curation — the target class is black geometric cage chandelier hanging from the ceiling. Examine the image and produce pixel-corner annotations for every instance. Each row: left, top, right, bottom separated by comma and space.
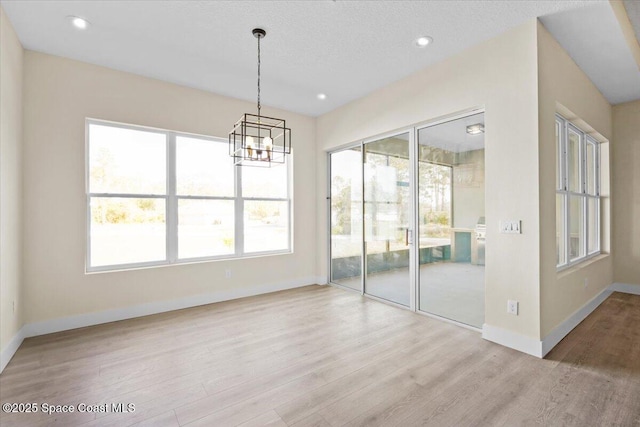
229, 28, 291, 167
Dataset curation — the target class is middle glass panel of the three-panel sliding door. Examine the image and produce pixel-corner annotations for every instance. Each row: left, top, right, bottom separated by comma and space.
364, 132, 412, 306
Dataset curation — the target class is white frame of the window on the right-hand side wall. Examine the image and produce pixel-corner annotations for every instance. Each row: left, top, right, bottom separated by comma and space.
555, 114, 602, 270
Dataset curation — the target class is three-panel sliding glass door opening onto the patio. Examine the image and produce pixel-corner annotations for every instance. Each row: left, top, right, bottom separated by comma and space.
329, 113, 485, 328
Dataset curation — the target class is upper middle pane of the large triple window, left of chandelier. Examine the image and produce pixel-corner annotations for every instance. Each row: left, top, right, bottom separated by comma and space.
176, 136, 235, 197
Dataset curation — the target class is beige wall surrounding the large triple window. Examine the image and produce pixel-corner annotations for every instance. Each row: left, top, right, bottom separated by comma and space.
24, 51, 317, 323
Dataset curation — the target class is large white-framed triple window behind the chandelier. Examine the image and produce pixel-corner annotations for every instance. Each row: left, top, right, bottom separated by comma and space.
87, 120, 291, 271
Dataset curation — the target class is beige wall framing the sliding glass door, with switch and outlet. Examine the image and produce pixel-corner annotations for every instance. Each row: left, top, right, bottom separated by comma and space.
317, 21, 540, 338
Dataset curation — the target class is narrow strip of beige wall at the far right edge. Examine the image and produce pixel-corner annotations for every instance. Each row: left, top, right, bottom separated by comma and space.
611, 101, 640, 285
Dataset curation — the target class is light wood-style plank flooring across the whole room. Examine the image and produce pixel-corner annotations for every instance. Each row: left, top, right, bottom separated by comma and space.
0, 286, 640, 427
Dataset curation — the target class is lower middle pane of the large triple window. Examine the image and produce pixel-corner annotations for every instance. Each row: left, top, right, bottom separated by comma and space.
178, 199, 235, 259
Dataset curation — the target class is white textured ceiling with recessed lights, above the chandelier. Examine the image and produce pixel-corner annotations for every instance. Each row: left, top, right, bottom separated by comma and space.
0, 0, 640, 116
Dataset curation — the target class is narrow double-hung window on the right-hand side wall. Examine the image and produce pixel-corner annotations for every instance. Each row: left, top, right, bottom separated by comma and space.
556, 116, 600, 267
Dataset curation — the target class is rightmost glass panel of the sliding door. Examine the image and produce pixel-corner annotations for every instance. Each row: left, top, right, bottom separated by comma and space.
417, 114, 485, 328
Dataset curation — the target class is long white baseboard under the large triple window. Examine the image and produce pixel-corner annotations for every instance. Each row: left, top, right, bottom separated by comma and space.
25, 277, 319, 340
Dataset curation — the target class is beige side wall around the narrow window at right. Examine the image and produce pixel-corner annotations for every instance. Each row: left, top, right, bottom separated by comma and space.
538, 23, 613, 338
